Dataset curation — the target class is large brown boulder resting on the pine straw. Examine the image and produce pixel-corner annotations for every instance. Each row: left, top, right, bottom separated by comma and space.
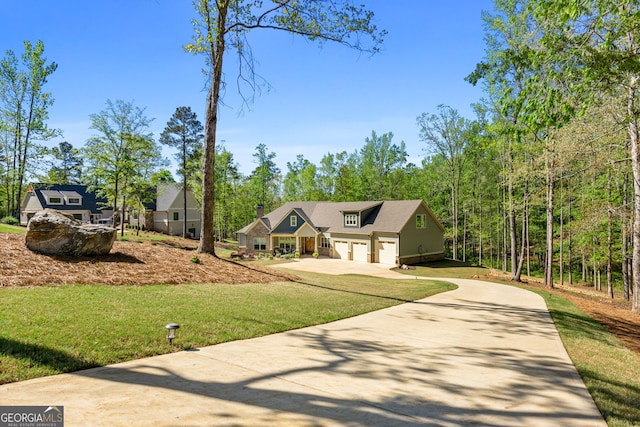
25, 209, 116, 256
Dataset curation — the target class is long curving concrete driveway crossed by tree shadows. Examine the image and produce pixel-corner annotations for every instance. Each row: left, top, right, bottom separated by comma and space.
0, 259, 606, 427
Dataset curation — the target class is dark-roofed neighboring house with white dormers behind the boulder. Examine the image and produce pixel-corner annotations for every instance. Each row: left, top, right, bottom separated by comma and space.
20, 183, 110, 225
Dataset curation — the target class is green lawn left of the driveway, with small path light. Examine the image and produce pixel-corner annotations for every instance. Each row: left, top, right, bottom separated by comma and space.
0, 274, 453, 383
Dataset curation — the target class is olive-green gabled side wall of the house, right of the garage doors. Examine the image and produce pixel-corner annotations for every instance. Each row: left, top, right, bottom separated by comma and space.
398, 206, 444, 264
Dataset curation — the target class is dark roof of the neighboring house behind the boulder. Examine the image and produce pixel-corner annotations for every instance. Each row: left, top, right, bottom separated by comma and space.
29, 183, 106, 214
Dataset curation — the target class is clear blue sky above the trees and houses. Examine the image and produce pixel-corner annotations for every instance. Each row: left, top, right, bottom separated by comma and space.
0, 0, 493, 174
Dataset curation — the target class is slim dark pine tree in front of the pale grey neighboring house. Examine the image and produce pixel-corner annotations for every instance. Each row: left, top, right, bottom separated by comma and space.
160, 107, 204, 238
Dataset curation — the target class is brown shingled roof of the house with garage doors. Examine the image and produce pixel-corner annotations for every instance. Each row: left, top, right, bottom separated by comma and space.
238, 200, 444, 235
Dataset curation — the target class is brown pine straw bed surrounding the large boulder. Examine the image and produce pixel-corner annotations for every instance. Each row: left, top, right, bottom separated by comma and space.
0, 233, 293, 287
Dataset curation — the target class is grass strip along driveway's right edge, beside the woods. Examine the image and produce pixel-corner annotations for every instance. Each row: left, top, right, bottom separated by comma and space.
398, 260, 640, 427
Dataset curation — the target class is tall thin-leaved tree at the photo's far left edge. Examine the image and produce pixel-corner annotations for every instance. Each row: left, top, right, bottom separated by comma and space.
0, 41, 58, 217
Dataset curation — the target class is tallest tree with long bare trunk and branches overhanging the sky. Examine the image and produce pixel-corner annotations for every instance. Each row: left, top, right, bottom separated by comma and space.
186, 0, 384, 254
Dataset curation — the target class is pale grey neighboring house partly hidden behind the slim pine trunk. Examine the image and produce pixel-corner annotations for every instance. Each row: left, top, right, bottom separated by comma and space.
149, 183, 200, 239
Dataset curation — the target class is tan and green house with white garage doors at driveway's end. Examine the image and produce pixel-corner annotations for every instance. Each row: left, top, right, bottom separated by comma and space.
238, 200, 444, 265
